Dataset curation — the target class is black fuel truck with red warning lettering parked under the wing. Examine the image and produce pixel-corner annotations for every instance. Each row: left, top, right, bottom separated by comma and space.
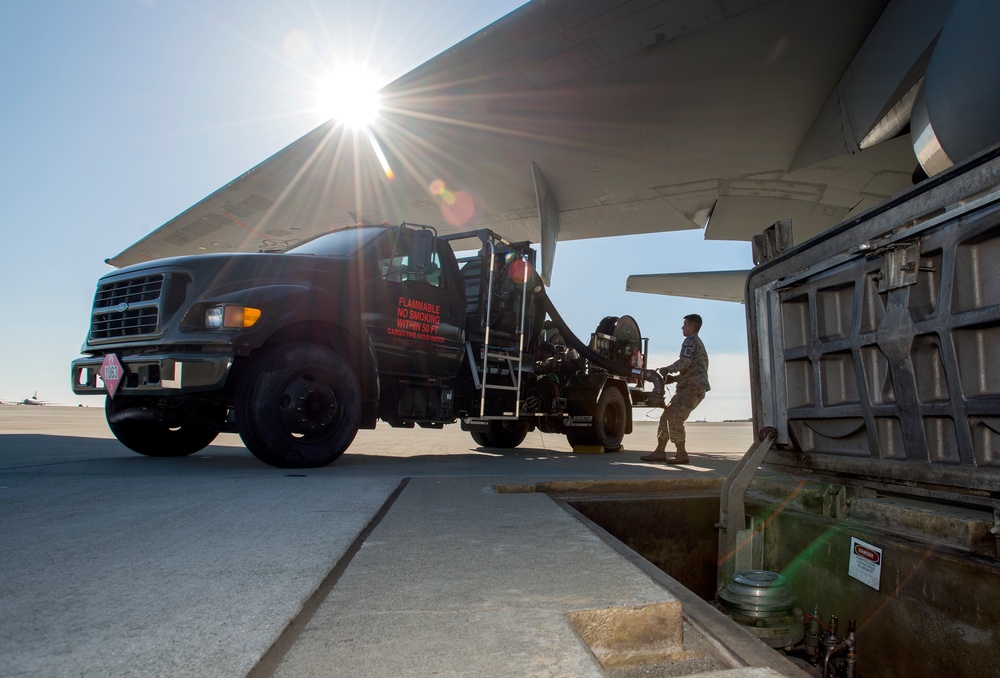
72, 223, 664, 468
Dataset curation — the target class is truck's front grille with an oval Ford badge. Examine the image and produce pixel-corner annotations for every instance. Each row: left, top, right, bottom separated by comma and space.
90, 274, 163, 341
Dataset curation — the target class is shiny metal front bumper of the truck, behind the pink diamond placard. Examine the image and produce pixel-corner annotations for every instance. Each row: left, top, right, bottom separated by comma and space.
71, 353, 233, 396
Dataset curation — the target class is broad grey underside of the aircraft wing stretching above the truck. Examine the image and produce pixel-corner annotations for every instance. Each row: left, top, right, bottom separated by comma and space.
109, 0, 910, 266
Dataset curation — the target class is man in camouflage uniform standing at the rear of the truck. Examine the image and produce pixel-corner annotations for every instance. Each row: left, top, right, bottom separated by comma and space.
640, 313, 711, 464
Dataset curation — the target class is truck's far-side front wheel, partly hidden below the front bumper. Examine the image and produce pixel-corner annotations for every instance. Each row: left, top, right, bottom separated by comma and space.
104, 397, 221, 457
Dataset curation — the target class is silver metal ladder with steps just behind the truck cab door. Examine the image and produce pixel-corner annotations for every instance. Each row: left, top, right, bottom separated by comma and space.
465, 232, 530, 421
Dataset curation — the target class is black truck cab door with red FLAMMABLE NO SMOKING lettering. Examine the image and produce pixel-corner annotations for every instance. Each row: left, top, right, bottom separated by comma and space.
365, 228, 465, 378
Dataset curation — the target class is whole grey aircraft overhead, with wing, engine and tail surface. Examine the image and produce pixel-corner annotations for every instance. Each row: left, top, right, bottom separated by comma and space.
108, 0, 1000, 301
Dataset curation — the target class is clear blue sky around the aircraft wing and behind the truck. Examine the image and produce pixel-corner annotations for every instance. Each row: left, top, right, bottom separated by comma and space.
0, 0, 751, 420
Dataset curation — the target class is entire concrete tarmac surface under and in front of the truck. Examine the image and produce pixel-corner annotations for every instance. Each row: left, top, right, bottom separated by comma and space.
0, 406, 787, 676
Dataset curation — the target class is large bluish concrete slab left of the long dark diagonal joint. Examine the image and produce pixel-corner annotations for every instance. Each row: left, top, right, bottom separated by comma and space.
0, 444, 397, 676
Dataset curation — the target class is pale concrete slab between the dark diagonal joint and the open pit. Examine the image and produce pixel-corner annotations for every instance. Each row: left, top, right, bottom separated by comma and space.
276, 478, 684, 677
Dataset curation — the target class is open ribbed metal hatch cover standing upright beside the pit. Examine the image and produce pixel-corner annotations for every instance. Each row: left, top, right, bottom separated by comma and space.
746, 148, 1000, 505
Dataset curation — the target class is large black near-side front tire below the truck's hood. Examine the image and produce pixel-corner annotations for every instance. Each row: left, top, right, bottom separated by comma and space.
235, 344, 361, 468
